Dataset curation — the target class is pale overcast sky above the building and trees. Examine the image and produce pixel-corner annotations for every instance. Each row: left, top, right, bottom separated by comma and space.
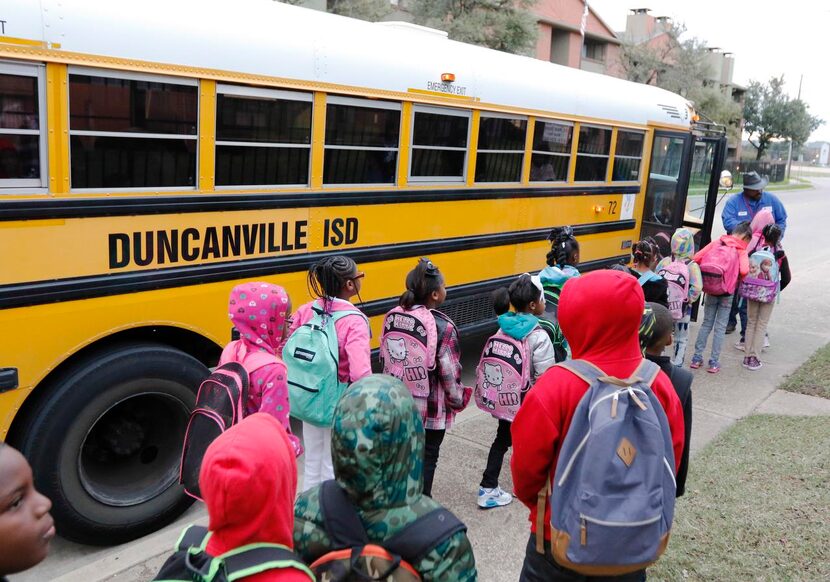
588, 0, 830, 141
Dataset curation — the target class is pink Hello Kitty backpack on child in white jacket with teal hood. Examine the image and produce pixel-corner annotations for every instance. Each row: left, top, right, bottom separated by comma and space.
475, 330, 531, 421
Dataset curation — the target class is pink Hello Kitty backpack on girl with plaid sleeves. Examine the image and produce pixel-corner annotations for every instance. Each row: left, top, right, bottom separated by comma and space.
380, 306, 438, 398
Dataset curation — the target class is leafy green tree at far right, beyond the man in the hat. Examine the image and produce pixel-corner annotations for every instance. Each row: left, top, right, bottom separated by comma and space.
744, 75, 824, 160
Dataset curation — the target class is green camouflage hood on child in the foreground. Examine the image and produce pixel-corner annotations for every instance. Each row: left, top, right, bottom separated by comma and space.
331, 374, 424, 512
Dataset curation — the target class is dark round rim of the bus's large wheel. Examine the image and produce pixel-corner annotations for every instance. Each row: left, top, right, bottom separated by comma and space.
78, 391, 190, 507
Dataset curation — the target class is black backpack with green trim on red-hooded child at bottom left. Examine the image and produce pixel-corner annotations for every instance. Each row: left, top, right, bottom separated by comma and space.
153, 525, 314, 582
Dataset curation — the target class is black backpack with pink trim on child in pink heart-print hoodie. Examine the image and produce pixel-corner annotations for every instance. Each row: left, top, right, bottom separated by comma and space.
179, 352, 277, 501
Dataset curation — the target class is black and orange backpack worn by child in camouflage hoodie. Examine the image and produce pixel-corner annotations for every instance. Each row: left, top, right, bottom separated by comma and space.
311, 480, 467, 582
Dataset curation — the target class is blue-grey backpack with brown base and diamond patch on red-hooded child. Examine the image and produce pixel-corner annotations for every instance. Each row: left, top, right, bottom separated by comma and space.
551, 360, 677, 576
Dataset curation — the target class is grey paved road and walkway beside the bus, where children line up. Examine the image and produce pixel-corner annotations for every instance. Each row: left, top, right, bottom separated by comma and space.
17, 182, 830, 582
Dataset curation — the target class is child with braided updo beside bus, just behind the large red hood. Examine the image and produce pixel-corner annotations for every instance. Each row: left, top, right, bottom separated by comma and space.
539, 226, 579, 362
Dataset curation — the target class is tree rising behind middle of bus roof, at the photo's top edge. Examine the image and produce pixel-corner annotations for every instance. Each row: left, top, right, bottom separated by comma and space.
408, 0, 537, 54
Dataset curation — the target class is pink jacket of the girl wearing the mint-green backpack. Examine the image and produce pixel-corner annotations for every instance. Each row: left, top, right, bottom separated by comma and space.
288, 298, 372, 384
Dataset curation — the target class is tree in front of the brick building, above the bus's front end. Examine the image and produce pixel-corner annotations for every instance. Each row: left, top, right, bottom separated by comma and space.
620, 23, 741, 140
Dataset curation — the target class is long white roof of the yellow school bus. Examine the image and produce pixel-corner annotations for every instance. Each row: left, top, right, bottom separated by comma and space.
4, 0, 691, 127
